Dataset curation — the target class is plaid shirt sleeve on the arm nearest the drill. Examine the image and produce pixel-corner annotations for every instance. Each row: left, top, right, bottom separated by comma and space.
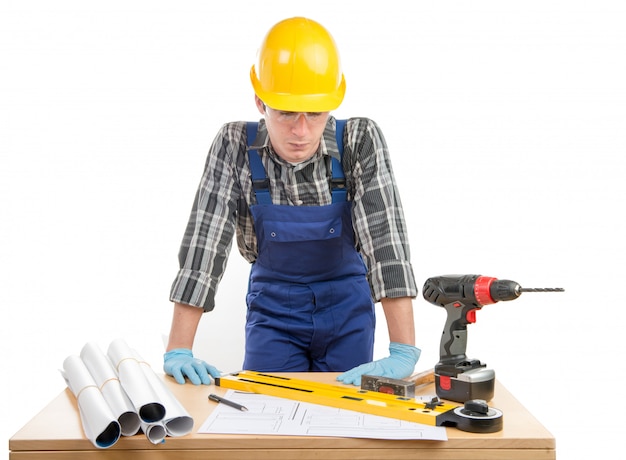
343, 118, 417, 301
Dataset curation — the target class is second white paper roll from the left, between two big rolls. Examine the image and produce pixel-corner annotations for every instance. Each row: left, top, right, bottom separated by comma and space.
80, 342, 141, 436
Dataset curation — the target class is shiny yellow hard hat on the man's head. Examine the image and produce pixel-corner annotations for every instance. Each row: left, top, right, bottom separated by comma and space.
250, 17, 346, 112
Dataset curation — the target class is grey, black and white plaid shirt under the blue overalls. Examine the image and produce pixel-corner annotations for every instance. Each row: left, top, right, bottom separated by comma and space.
170, 116, 417, 311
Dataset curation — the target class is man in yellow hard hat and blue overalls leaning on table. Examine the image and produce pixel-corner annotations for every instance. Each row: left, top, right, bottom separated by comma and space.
164, 18, 420, 385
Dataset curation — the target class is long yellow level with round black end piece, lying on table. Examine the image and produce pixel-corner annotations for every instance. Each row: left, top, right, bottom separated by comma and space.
215, 371, 502, 433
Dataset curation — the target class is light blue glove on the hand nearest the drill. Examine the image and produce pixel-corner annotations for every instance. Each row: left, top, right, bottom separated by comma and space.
337, 342, 421, 385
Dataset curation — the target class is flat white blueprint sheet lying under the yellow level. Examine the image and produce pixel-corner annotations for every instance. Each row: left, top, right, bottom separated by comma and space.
198, 390, 448, 441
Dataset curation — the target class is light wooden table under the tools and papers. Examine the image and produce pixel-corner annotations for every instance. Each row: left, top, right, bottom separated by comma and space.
9, 373, 556, 460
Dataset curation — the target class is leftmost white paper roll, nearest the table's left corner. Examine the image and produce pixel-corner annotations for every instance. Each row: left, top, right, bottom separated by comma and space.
62, 355, 122, 449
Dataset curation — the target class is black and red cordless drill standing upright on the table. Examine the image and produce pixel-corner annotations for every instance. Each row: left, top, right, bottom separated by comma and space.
422, 275, 563, 403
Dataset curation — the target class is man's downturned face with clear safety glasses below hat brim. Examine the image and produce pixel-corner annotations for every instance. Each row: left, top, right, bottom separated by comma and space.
256, 97, 329, 163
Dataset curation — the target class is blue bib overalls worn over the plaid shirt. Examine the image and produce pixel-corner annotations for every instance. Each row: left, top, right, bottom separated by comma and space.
243, 120, 375, 372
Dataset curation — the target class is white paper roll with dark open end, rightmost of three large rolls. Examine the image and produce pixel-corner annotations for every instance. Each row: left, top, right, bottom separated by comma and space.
107, 339, 165, 423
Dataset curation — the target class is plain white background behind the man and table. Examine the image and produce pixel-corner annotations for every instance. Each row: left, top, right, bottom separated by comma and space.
0, 0, 626, 459
